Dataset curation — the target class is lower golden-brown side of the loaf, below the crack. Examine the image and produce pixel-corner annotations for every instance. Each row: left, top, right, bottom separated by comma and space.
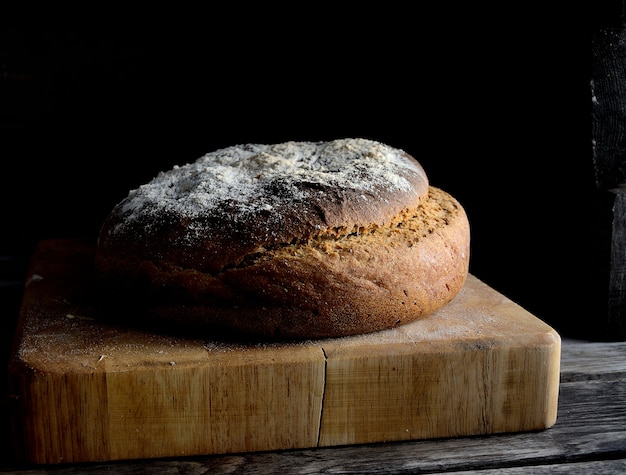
95, 186, 470, 339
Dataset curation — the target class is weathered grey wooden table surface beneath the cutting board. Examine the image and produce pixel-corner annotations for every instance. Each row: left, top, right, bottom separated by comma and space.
0, 251, 626, 475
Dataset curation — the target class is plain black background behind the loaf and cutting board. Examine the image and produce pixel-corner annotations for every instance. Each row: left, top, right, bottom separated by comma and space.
0, 2, 607, 336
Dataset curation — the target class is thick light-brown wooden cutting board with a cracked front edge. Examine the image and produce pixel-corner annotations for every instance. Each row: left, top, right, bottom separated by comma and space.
9, 240, 561, 463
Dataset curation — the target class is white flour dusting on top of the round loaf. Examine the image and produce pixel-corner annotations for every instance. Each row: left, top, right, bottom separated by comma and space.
112, 139, 428, 234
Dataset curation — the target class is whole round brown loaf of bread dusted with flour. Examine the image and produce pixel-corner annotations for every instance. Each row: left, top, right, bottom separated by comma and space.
94, 139, 470, 339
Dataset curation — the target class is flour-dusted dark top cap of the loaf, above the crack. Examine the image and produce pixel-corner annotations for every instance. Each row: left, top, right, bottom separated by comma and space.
100, 139, 428, 272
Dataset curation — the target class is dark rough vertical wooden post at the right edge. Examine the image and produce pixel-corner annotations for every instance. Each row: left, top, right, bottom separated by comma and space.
591, 0, 626, 340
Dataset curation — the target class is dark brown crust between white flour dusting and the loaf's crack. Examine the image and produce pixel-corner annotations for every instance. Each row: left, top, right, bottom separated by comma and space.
98, 152, 428, 273
